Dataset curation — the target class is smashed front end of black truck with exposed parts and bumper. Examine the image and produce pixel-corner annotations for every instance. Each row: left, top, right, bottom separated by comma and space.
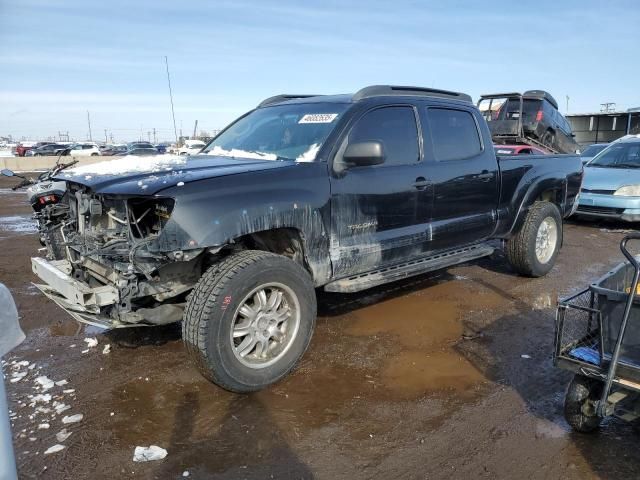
31, 183, 204, 328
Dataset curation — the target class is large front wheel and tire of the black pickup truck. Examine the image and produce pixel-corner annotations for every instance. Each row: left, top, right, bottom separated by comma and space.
182, 250, 316, 393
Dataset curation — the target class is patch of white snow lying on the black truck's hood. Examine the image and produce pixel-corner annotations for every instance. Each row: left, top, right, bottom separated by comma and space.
65, 155, 187, 177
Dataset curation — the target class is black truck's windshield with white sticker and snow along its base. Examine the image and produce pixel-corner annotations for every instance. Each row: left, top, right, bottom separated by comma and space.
202, 103, 349, 162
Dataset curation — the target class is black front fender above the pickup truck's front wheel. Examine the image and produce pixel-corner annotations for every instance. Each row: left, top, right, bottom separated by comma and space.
153, 162, 331, 284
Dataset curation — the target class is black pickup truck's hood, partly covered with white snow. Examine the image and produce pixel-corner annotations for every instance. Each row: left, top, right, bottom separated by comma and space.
55, 155, 295, 195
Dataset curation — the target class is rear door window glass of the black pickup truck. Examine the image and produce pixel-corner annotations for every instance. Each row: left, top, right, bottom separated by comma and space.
427, 108, 482, 162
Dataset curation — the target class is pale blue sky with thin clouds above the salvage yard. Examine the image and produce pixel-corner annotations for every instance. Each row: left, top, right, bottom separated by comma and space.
0, 0, 640, 140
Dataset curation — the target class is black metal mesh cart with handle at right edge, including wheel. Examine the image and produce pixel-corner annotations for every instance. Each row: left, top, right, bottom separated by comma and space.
554, 233, 640, 432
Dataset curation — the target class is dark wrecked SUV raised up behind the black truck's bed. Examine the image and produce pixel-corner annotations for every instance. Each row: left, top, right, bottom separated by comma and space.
478, 90, 580, 153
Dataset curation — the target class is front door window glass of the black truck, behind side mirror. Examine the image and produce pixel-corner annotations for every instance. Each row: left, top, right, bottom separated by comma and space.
349, 107, 420, 166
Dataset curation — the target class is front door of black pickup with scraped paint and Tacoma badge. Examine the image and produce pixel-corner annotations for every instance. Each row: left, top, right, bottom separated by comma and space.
330, 105, 433, 278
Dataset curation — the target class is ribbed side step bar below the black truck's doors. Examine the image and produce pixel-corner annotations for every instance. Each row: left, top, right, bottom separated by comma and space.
324, 244, 495, 293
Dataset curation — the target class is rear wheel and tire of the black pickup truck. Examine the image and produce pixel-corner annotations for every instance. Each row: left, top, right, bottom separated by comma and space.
506, 202, 562, 277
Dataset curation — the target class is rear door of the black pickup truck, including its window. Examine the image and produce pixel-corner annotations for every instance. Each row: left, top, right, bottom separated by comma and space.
421, 106, 499, 250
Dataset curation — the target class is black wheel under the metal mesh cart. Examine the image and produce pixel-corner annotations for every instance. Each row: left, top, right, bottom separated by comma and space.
564, 375, 602, 433
